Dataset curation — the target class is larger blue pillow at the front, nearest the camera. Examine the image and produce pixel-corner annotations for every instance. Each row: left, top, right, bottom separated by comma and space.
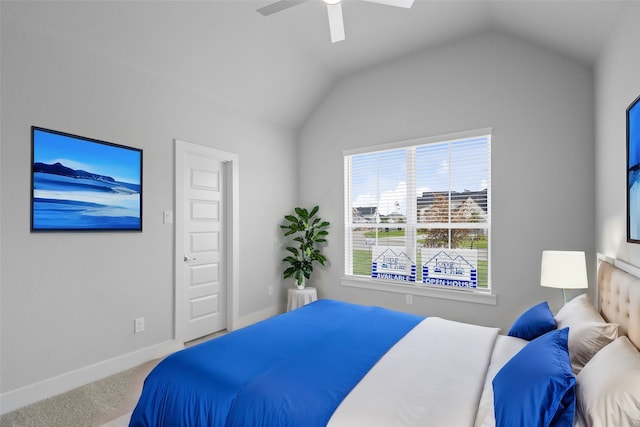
493, 328, 576, 427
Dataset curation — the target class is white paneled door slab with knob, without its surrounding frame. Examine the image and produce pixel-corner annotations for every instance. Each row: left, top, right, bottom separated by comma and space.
182, 153, 227, 342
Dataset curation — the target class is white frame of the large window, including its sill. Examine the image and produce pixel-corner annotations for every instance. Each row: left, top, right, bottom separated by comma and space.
341, 127, 496, 305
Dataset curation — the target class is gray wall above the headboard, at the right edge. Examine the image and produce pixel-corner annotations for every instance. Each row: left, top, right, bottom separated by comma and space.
596, 2, 640, 266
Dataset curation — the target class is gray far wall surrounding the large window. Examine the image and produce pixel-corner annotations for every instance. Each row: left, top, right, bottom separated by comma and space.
298, 32, 595, 328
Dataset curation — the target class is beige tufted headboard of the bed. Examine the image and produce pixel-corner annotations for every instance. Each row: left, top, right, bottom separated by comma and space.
598, 260, 640, 349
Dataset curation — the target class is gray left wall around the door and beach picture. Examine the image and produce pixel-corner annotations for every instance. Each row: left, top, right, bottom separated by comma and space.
0, 9, 297, 393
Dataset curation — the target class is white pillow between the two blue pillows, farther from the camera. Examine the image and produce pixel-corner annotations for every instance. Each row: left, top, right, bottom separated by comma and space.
555, 294, 618, 375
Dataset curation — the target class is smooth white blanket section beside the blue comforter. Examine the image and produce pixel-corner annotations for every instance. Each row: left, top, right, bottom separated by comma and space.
328, 317, 498, 427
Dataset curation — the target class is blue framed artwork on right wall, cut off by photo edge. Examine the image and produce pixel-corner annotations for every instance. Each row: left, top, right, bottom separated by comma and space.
627, 96, 640, 243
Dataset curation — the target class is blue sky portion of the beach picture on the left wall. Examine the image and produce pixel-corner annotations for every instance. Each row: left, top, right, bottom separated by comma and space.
33, 129, 142, 184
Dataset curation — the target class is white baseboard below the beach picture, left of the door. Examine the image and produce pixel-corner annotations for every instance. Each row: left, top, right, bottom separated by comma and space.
0, 340, 184, 415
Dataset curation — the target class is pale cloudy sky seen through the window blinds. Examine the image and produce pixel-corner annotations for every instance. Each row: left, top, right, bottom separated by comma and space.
351, 137, 490, 215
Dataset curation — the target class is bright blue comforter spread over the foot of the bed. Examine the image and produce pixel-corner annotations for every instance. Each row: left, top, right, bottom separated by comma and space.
129, 300, 423, 427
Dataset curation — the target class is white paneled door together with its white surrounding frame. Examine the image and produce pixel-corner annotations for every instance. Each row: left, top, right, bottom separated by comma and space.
174, 140, 240, 343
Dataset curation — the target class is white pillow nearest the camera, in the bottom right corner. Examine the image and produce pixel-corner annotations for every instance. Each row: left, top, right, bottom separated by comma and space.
576, 337, 640, 427
